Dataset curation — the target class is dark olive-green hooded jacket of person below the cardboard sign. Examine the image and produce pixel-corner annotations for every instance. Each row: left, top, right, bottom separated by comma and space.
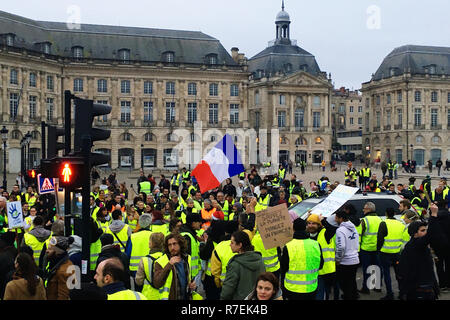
220, 251, 266, 300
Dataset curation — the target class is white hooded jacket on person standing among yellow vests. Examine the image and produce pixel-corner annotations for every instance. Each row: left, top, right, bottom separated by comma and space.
336, 221, 359, 265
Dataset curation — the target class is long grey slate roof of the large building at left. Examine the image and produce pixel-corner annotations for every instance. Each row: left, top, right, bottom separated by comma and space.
0, 11, 237, 66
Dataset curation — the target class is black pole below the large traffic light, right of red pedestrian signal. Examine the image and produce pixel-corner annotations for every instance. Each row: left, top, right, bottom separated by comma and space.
81, 135, 92, 282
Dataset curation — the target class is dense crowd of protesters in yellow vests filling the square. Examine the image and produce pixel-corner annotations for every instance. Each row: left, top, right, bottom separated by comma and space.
0, 162, 450, 300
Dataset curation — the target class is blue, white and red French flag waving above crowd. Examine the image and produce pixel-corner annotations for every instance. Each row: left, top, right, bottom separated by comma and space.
192, 134, 245, 193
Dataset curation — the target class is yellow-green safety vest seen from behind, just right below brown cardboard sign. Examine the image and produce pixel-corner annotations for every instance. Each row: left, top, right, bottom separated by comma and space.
284, 239, 321, 293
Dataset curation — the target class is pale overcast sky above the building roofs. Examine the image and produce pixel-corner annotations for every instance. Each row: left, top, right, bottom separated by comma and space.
0, 0, 450, 89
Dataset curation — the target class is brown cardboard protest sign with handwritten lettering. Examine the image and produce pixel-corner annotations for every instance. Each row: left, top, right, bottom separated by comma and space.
255, 203, 294, 250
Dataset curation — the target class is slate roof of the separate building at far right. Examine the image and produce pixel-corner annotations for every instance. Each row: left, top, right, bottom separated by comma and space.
372, 45, 450, 81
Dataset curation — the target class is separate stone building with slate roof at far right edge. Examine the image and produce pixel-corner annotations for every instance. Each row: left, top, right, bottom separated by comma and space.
361, 45, 450, 166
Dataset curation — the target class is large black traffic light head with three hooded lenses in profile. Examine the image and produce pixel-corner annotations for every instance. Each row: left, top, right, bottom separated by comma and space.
74, 97, 112, 166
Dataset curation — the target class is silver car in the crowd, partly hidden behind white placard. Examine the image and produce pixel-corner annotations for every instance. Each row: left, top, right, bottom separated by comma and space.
289, 192, 417, 221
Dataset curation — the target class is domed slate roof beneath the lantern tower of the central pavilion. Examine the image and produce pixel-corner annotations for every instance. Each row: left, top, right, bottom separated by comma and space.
248, 43, 321, 78
